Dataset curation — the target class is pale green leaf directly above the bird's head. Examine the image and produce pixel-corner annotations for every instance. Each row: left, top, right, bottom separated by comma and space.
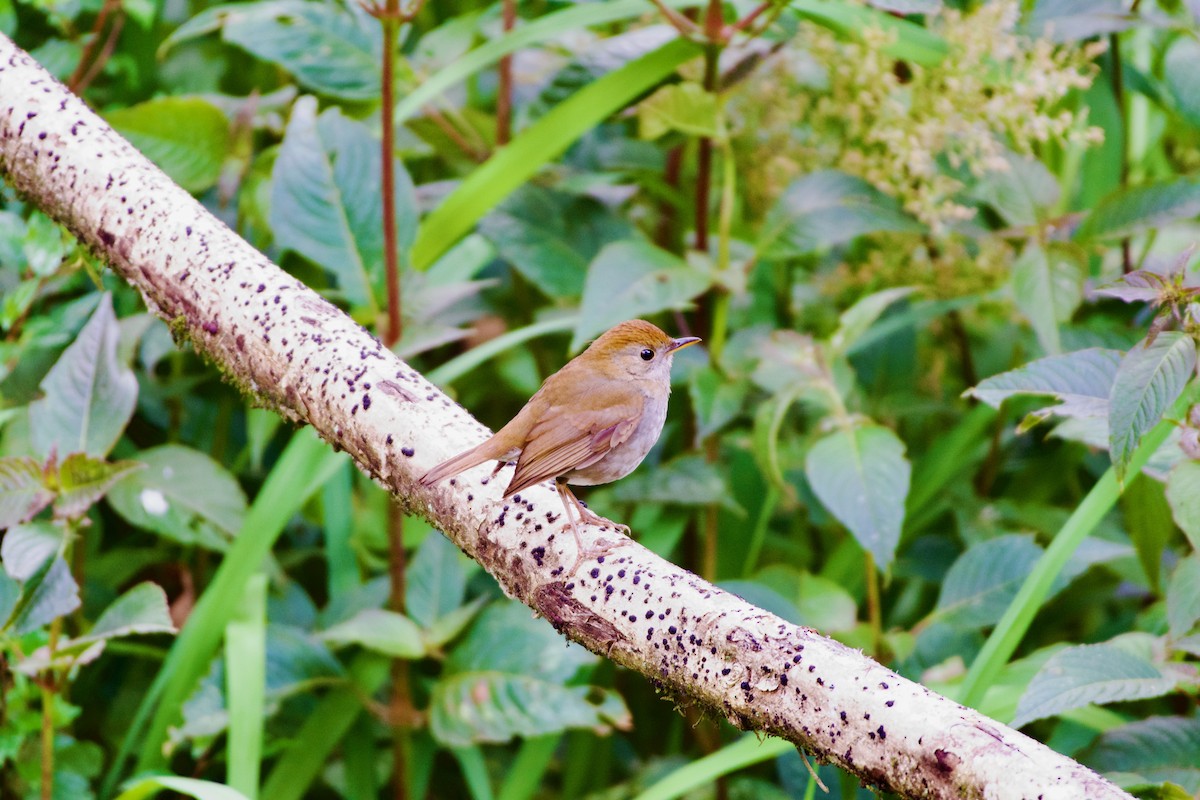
571, 241, 712, 353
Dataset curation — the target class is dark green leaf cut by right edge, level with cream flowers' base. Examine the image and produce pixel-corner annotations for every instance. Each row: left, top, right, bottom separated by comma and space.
1076, 178, 1200, 240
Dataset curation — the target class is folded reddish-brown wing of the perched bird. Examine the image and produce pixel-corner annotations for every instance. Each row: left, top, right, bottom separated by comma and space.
504, 385, 643, 497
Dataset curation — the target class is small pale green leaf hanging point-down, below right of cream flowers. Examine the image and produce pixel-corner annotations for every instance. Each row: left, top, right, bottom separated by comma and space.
1013, 241, 1084, 355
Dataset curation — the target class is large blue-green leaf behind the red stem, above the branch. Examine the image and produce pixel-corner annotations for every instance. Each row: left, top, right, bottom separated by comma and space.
270, 97, 416, 307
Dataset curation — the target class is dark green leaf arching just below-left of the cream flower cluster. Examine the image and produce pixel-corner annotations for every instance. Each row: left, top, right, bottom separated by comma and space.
758, 170, 924, 259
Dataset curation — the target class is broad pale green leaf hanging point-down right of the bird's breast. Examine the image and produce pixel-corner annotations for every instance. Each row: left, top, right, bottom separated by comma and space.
804, 425, 912, 569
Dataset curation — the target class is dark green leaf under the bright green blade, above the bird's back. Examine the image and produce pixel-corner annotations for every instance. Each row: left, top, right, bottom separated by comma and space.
479, 185, 638, 297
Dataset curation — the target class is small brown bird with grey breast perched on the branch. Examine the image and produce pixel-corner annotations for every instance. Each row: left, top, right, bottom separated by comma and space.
421, 319, 700, 572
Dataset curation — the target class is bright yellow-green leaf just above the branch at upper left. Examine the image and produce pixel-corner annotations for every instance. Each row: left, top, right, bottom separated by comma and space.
106, 97, 232, 194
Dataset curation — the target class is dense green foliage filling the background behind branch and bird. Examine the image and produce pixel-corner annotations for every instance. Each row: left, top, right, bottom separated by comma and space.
0, 0, 1200, 800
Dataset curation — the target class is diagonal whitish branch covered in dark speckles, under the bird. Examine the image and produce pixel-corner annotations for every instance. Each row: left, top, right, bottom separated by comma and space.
0, 35, 1129, 800
